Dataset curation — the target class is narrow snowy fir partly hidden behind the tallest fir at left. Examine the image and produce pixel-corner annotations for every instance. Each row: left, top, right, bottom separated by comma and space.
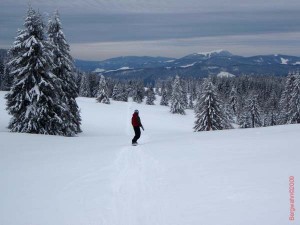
48, 11, 81, 136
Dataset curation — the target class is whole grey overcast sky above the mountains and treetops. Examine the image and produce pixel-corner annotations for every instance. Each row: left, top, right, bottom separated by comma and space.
0, 0, 300, 60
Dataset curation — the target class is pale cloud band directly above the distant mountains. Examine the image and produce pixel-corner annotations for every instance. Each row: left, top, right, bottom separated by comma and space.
71, 32, 300, 60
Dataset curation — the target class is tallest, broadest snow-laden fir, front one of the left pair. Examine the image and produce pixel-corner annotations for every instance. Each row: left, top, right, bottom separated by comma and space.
6, 7, 68, 135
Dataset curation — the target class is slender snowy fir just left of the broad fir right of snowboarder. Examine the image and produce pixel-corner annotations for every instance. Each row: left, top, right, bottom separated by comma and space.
170, 76, 186, 115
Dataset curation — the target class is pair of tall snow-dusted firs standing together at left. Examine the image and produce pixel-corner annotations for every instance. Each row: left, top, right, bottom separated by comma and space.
6, 7, 81, 136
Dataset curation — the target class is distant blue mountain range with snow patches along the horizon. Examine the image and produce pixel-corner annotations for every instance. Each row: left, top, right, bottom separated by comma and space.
75, 50, 300, 79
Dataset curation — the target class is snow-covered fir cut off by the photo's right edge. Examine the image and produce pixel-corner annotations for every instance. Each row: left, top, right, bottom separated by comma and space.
287, 71, 300, 124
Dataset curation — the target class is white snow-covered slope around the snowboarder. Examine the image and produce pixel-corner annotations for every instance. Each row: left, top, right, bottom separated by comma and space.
0, 92, 300, 225
